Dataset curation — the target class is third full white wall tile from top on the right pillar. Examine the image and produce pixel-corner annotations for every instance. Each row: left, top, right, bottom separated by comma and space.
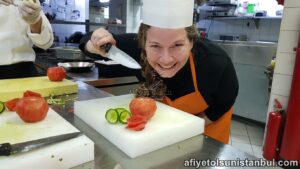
274, 53, 296, 75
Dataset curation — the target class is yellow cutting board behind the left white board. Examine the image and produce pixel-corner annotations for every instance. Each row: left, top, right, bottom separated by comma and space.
0, 76, 78, 102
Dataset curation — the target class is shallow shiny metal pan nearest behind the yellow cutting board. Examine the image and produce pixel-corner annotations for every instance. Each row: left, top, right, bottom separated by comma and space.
57, 62, 95, 72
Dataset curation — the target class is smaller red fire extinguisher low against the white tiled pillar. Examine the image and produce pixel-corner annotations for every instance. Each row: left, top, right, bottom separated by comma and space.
263, 99, 284, 161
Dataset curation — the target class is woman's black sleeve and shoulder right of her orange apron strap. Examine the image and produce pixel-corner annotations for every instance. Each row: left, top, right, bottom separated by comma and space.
193, 40, 239, 121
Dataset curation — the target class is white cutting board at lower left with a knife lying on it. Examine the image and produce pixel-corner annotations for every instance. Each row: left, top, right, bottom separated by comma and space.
0, 109, 94, 169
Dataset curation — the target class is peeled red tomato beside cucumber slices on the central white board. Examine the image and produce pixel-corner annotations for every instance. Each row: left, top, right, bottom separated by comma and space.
129, 97, 157, 120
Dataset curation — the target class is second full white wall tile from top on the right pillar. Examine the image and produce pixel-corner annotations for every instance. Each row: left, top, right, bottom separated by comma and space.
277, 30, 299, 53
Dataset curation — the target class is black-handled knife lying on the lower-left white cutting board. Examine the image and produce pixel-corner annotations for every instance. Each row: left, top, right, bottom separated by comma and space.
0, 132, 82, 156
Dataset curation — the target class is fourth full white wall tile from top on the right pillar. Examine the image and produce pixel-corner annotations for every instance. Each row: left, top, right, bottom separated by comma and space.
271, 73, 293, 96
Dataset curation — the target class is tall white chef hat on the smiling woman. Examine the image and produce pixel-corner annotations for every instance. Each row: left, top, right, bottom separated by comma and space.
142, 0, 194, 28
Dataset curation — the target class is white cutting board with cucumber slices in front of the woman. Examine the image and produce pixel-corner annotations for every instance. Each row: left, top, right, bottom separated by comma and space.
74, 95, 204, 158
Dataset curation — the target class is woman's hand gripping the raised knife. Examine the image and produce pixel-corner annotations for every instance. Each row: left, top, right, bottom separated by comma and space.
86, 28, 116, 57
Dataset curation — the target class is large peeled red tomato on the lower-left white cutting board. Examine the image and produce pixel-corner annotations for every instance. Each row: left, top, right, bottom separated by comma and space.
15, 96, 49, 123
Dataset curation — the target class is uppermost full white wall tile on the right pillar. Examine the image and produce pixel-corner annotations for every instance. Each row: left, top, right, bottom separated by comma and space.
281, 7, 300, 31
